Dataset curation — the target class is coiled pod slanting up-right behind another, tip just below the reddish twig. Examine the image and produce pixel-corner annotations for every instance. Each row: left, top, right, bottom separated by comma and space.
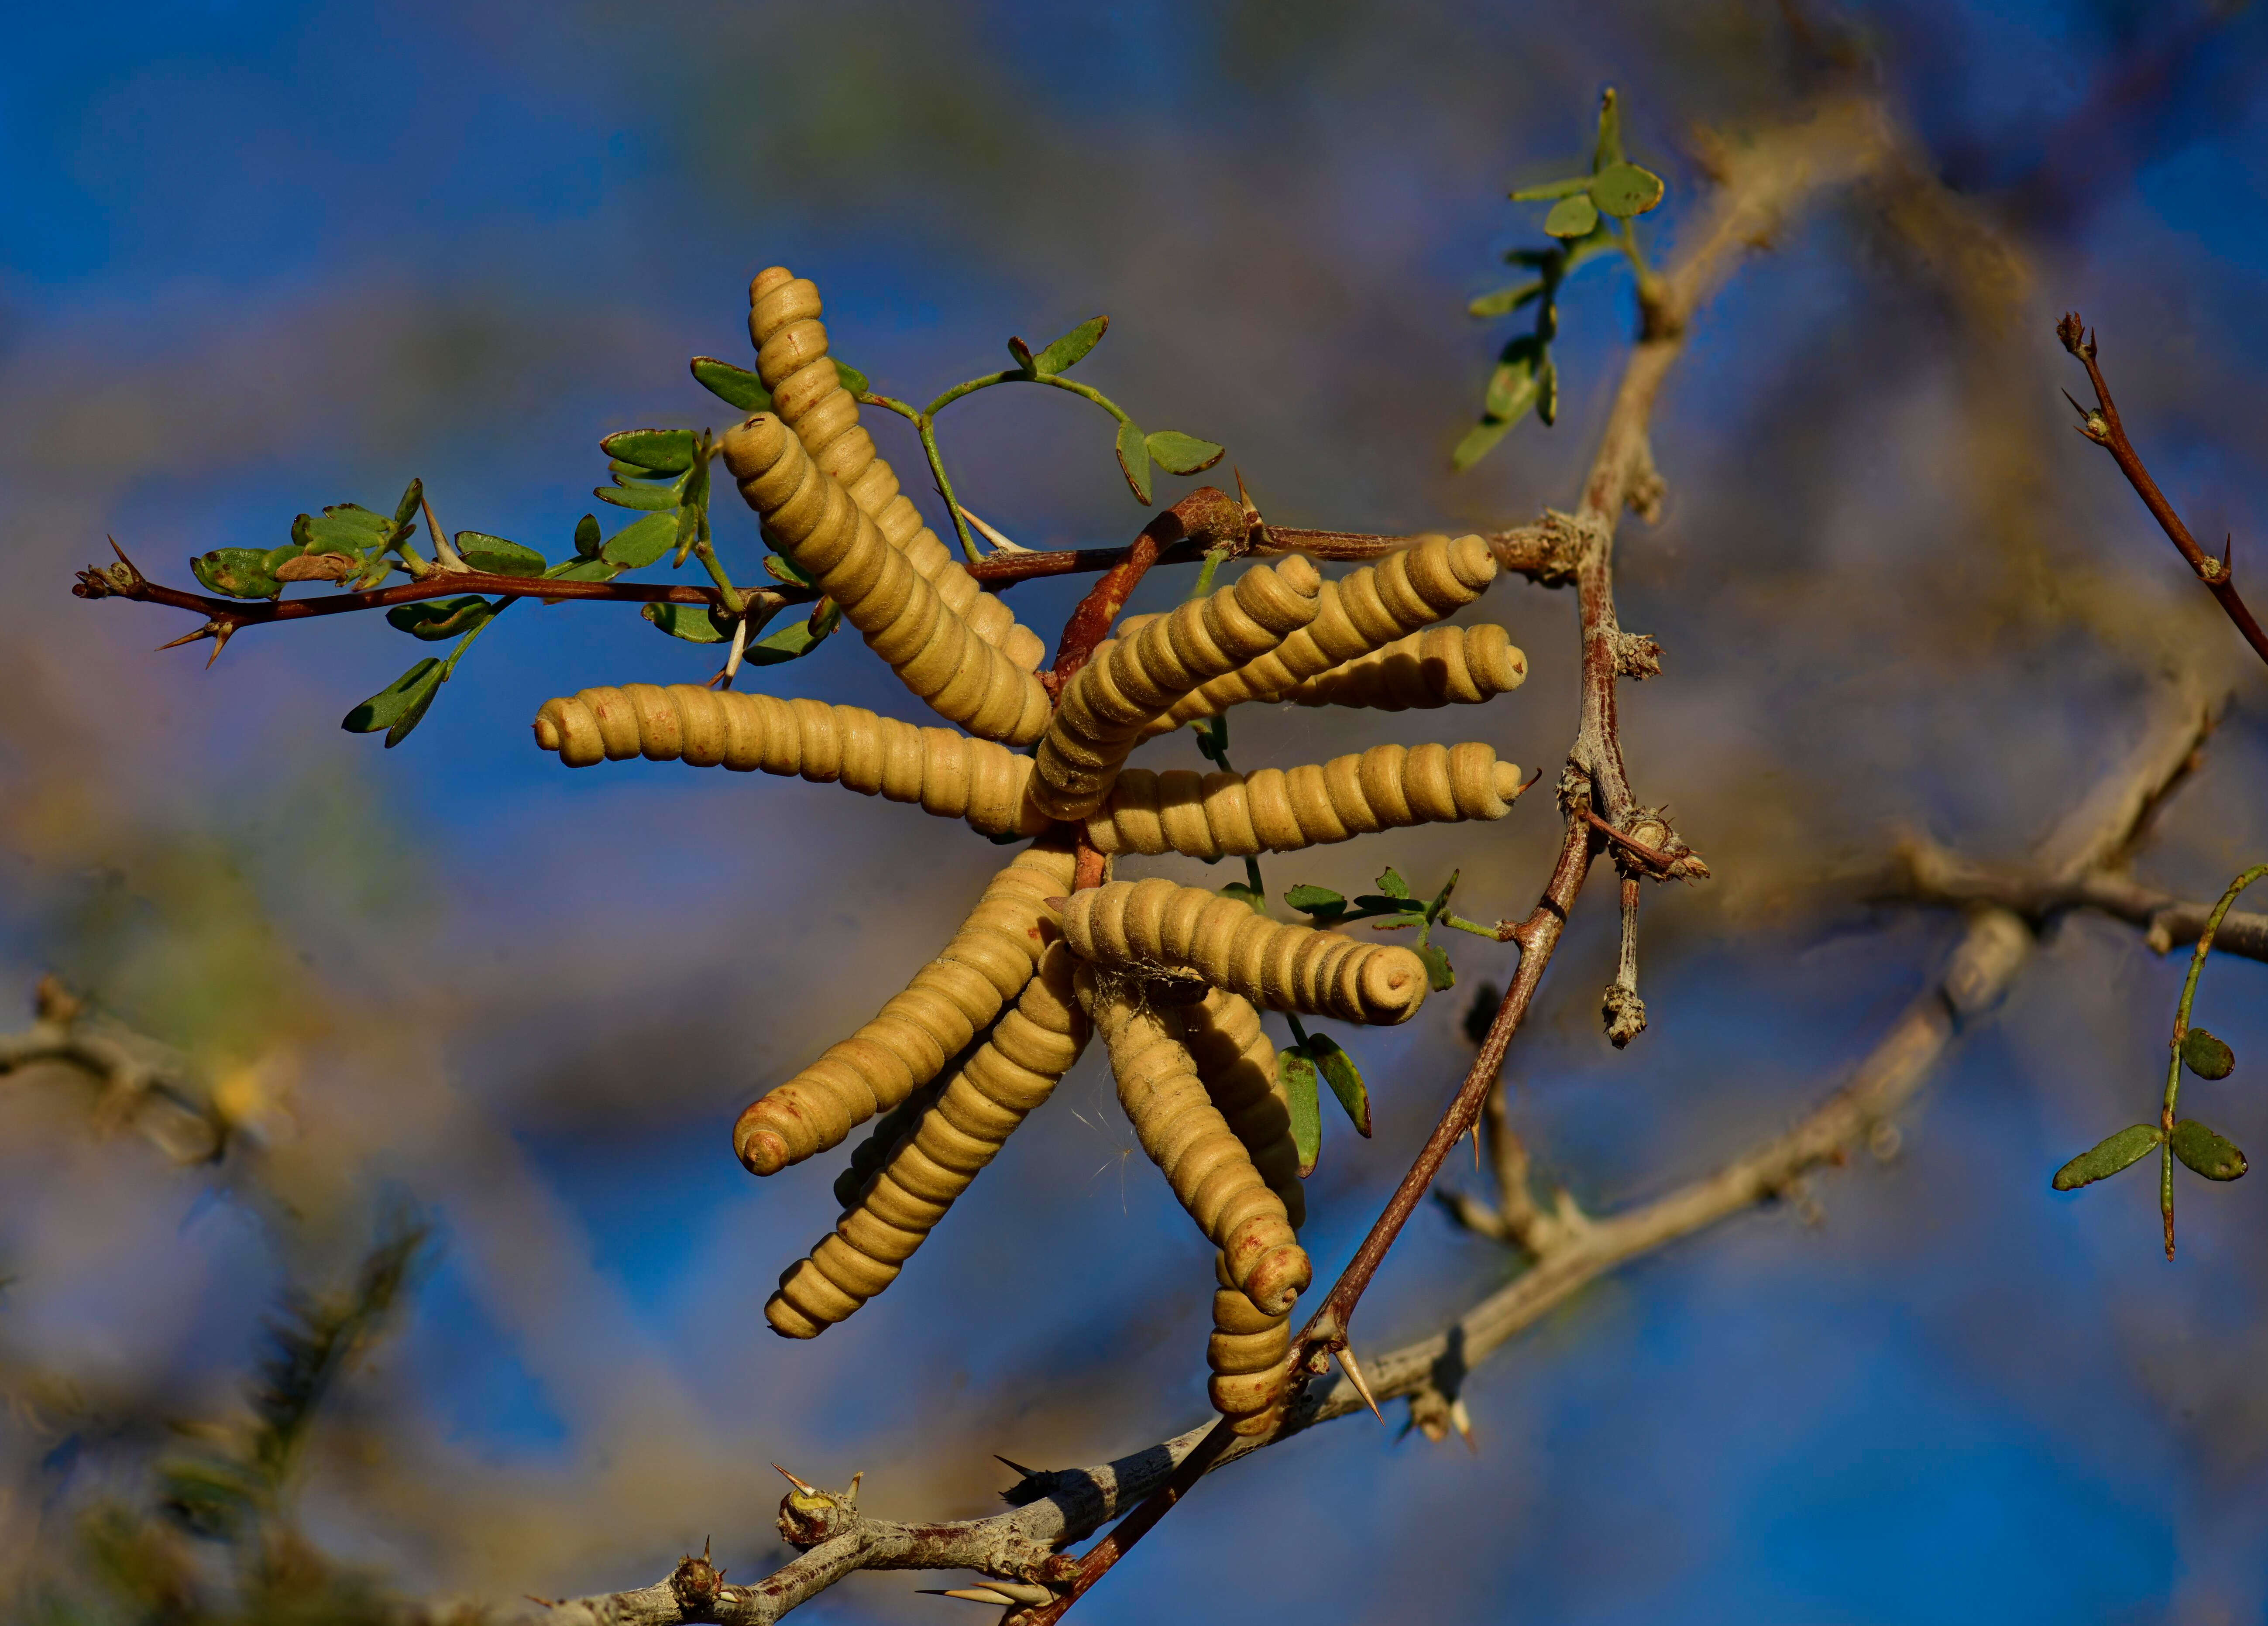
1123, 535, 1497, 735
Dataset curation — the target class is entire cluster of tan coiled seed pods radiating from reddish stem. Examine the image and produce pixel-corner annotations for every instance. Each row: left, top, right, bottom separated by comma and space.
535, 268, 1526, 1435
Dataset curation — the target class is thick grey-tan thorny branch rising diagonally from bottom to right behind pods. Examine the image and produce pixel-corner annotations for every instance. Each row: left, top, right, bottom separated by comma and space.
551, 690, 2211, 1626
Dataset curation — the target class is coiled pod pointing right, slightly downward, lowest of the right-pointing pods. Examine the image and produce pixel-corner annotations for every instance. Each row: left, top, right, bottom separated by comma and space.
1064, 875, 1426, 1025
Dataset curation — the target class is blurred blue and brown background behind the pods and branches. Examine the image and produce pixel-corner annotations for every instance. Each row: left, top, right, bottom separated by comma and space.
0, 0, 2268, 1624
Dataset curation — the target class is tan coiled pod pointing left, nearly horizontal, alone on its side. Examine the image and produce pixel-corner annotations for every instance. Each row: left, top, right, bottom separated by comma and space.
535, 683, 1048, 834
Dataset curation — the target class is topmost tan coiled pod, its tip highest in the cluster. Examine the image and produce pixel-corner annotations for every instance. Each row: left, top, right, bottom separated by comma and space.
749, 265, 1045, 671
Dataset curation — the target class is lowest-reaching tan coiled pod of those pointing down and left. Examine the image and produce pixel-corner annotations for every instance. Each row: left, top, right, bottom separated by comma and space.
764, 943, 1089, 1338
